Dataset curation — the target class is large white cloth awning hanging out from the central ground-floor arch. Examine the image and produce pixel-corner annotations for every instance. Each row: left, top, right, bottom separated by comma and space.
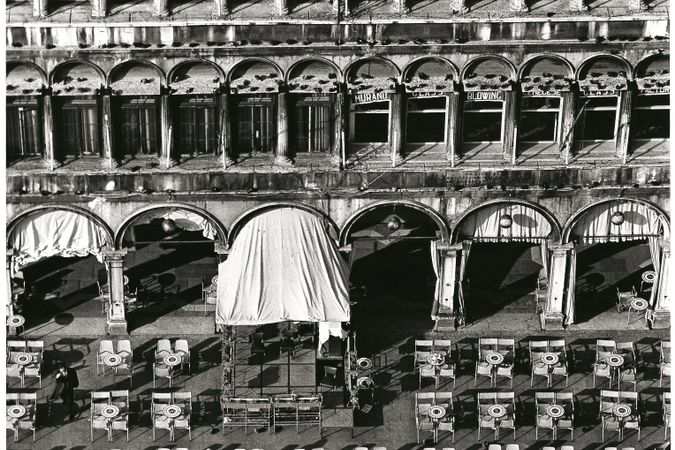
216, 208, 349, 325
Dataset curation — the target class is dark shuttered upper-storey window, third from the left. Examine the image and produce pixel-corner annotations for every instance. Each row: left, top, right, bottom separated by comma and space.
115, 97, 159, 155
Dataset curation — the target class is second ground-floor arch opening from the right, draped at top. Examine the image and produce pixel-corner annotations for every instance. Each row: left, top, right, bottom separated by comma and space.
453, 200, 560, 324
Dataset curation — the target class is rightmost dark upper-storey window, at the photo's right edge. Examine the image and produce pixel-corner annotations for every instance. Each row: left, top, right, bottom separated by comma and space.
631, 95, 670, 139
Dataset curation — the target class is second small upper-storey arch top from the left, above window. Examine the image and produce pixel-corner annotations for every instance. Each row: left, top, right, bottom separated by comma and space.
49, 59, 108, 95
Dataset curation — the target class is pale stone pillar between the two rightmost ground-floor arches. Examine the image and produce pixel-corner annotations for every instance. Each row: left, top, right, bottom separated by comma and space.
541, 244, 573, 330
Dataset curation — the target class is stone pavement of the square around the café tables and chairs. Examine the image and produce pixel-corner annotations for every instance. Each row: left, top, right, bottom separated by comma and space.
6, 316, 670, 450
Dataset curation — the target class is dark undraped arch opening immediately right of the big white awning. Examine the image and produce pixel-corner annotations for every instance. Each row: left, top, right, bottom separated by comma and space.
341, 202, 447, 354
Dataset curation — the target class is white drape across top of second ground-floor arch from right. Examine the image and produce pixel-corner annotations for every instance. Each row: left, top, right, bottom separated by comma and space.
459, 203, 551, 242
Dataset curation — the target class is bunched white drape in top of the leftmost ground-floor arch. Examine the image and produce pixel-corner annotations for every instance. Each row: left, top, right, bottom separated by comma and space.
8, 210, 112, 268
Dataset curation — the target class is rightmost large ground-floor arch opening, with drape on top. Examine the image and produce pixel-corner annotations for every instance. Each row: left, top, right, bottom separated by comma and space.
563, 198, 669, 328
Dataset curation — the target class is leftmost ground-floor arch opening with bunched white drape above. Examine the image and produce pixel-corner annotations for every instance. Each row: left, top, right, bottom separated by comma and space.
7, 205, 113, 331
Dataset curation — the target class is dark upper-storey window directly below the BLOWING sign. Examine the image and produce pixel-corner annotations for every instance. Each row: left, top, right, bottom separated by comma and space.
463, 101, 503, 142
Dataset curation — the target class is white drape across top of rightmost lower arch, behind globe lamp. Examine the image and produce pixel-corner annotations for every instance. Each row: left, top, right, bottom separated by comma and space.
572, 200, 665, 244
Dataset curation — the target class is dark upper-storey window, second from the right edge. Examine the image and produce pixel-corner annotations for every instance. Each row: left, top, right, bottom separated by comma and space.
575, 97, 618, 141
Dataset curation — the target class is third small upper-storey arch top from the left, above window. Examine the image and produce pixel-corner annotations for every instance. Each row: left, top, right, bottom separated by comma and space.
108, 59, 166, 95
